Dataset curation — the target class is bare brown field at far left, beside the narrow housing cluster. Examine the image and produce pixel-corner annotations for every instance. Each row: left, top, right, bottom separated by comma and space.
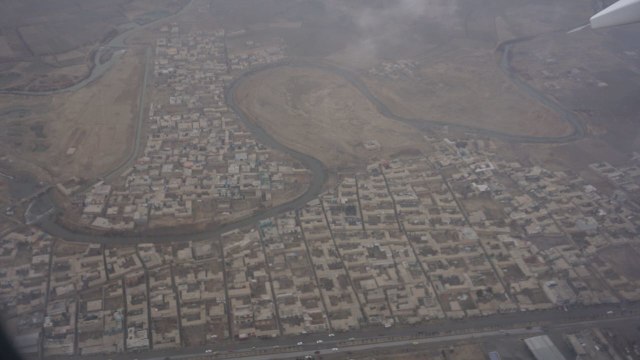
0, 50, 144, 181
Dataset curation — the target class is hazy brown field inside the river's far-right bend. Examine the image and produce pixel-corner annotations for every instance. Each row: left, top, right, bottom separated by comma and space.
364, 43, 570, 136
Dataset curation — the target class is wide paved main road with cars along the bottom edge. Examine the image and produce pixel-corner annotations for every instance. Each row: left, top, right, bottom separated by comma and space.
56, 304, 640, 360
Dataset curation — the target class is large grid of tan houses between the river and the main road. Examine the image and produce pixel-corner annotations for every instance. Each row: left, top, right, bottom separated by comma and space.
0, 139, 640, 355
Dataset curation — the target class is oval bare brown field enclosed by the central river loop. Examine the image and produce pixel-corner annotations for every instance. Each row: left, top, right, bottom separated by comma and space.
237, 67, 425, 169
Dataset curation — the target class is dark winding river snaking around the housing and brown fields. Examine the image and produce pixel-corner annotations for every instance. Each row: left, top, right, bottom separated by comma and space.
39, 31, 585, 244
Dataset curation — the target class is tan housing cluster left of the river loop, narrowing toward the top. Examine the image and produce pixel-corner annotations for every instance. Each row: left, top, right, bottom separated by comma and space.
81, 25, 308, 230
